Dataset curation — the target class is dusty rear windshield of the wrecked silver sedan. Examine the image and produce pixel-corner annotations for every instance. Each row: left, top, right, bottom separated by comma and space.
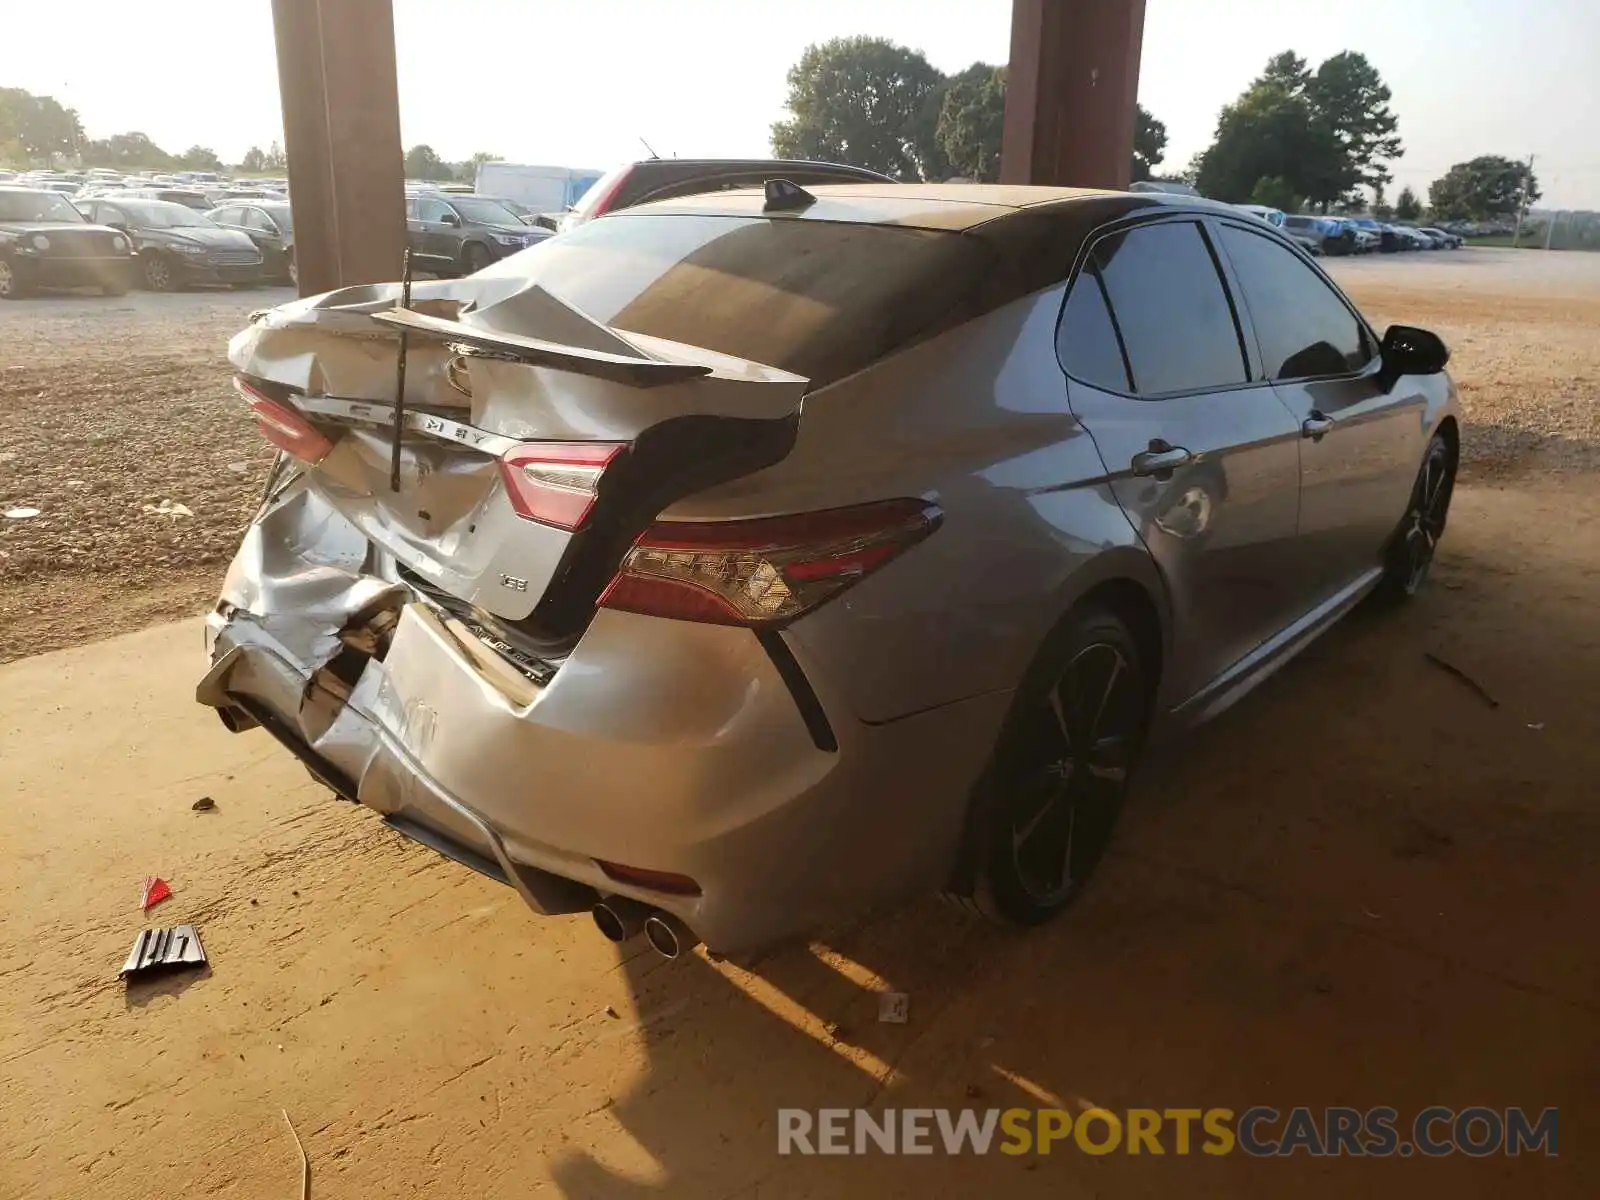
480, 213, 997, 387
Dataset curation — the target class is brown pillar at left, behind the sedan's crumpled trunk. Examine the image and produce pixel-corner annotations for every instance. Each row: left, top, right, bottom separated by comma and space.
272, 0, 406, 296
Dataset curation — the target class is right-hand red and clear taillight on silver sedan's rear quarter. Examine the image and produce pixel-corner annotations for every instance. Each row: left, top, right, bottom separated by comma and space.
600, 499, 942, 627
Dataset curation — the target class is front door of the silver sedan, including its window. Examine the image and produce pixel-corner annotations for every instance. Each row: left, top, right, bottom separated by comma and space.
1218, 221, 1427, 600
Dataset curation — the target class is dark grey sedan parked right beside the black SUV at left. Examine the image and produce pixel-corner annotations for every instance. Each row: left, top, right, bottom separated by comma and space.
88, 197, 261, 291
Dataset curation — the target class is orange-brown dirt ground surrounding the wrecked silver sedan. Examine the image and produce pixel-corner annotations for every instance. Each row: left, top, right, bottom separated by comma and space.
0, 251, 1600, 1200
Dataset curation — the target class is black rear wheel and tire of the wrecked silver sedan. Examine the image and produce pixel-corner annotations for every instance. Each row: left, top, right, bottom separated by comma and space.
947, 608, 1154, 926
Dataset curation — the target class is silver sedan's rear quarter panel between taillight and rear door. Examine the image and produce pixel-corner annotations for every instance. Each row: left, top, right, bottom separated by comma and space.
652, 288, 1162, 722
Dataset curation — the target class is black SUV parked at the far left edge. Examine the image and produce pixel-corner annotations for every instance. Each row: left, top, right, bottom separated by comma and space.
0, 186, 134, 301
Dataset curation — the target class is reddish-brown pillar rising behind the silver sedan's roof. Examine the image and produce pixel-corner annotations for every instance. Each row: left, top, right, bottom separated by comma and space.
1000, 0, 1144, 187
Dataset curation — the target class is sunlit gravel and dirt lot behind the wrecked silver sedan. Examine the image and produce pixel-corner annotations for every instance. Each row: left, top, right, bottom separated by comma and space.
0, 250, 1600, 661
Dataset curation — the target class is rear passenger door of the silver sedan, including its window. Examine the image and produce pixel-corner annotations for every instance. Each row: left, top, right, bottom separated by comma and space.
1059, 218, 1299, 704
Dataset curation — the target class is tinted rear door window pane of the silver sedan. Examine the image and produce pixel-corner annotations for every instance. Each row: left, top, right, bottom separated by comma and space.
1094, 221, 1245, 395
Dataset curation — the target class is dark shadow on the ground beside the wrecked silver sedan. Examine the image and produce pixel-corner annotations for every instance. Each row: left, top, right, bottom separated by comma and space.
552, 524, 1600, 1200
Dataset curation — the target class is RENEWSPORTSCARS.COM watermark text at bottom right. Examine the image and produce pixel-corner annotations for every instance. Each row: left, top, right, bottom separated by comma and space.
778, 1106, 1560, 1158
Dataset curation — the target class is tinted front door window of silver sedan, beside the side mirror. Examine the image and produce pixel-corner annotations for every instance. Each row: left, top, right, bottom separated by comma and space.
1222, 226, 1373, 379
